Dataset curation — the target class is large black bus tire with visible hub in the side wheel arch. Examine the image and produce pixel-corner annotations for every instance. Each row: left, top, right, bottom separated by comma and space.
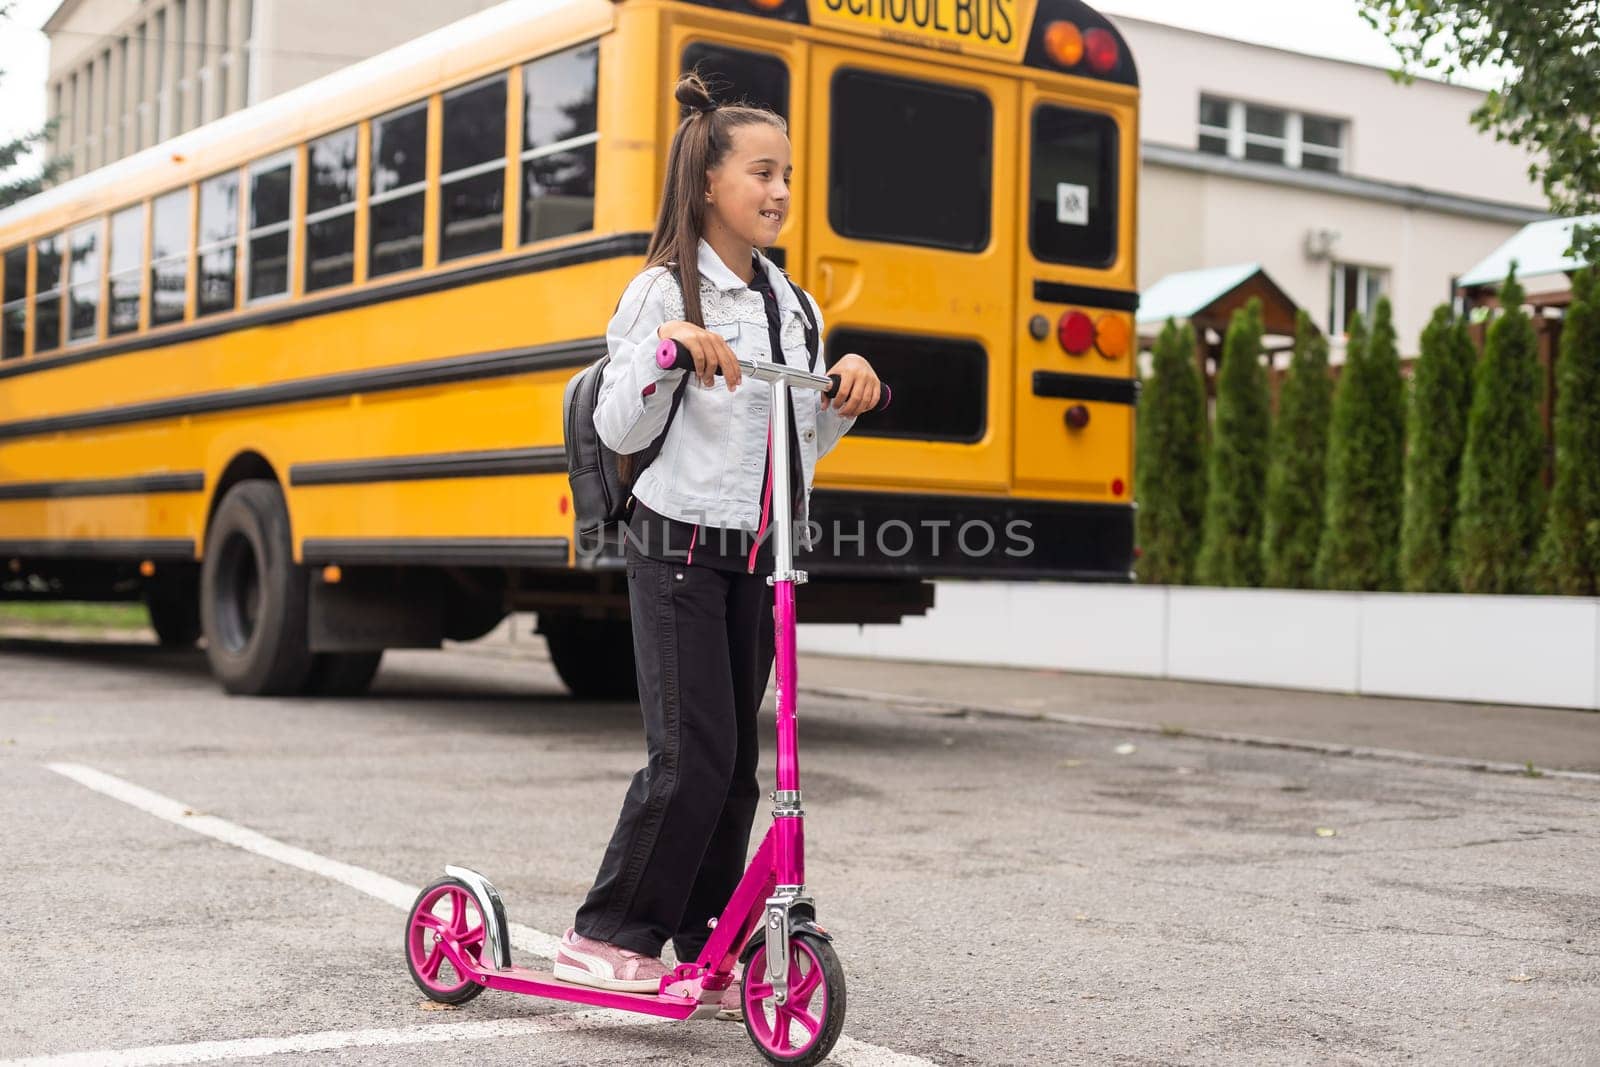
200, 480, 312, 696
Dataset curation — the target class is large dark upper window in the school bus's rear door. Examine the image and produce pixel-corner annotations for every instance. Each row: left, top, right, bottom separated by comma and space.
827, 70, 994, 251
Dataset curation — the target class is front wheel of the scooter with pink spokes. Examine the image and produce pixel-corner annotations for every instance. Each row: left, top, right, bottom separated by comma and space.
744, 931, 845, 1065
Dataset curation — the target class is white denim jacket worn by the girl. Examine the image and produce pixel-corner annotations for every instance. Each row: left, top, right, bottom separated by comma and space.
595, 240, 854, 531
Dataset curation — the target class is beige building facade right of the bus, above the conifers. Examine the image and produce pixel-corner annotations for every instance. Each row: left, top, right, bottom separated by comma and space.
1114, 18, 1546, 358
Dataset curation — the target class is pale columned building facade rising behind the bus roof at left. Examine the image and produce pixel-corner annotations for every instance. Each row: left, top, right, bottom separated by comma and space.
43, 0, 496, 176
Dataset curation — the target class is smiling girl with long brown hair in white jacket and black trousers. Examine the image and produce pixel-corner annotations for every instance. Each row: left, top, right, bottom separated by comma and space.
554, 74, 880, 1017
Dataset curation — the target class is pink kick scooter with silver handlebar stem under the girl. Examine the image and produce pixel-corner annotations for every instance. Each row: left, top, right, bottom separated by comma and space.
405, 341, 890, 1064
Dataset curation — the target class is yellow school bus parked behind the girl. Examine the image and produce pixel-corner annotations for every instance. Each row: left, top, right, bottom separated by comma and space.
0, 0, 1139, 696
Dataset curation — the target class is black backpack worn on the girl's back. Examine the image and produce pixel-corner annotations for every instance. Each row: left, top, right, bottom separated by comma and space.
562, 274, 818, 557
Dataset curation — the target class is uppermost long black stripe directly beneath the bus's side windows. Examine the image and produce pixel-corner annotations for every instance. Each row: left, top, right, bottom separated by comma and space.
0, 234, 650, 379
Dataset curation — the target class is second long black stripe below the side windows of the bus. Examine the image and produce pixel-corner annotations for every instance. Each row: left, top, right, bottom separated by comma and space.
0, 338, 605, 440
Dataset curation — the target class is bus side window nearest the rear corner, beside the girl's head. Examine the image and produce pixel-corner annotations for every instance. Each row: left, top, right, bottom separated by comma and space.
522, 45, 600, 245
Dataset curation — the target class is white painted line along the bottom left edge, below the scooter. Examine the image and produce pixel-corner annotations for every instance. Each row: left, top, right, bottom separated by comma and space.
0, 1009, 658, 1067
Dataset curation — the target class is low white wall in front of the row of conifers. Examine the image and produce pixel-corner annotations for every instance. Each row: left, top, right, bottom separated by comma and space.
798, 581, 1600, 710
